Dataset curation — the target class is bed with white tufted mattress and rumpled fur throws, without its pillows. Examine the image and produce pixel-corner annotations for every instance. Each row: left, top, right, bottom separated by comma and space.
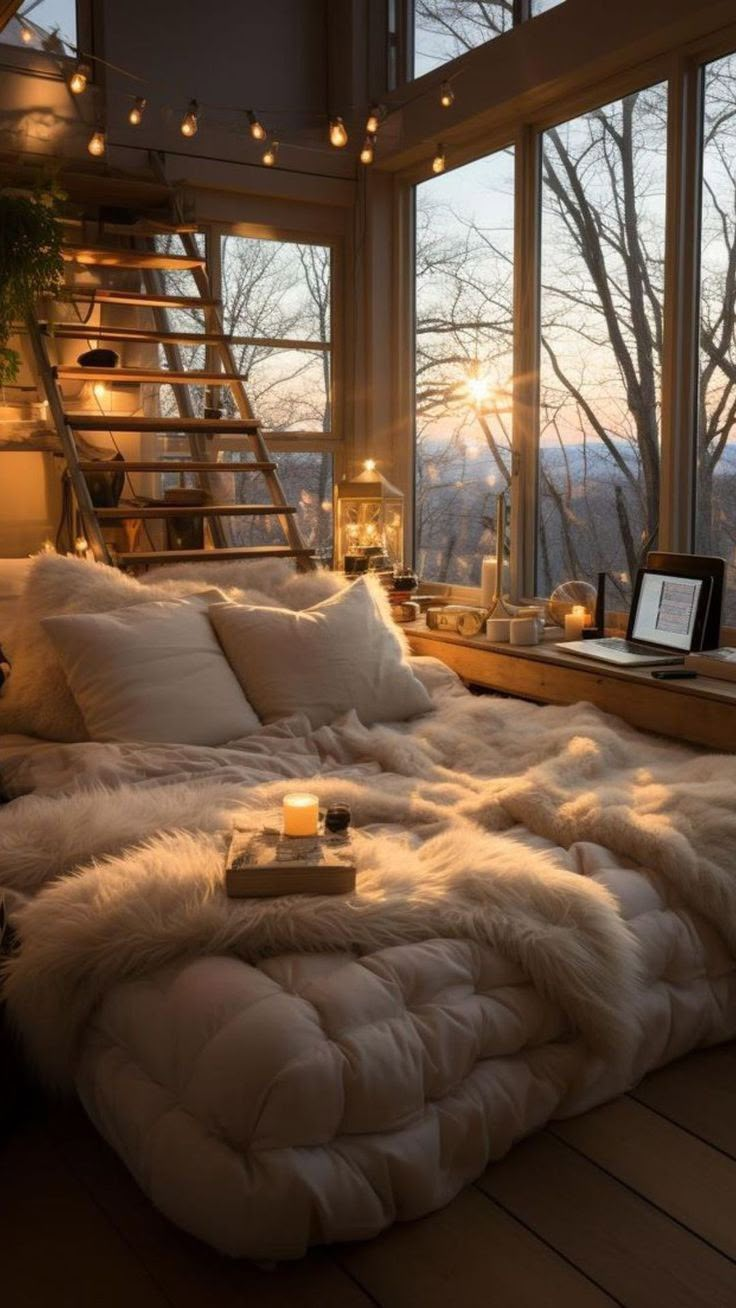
0, 549, 736, 1260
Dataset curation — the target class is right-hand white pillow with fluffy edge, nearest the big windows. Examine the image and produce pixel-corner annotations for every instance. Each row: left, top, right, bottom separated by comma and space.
208, 577, 431, 727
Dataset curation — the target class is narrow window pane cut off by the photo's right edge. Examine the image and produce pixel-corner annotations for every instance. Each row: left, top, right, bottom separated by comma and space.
695, 55, 736, 624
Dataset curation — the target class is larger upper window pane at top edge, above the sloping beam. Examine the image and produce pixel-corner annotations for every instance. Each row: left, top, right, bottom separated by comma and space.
414, 0, 514, 77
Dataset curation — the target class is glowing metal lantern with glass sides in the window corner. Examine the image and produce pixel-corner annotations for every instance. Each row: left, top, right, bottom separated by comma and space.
335, 459, 404, 573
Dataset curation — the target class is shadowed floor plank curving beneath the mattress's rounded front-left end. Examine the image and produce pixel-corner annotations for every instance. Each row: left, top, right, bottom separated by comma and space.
50, 1110, 371, 1308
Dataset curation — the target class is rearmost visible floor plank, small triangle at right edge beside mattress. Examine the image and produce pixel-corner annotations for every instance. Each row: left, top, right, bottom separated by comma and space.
633, 1044, 736, 1159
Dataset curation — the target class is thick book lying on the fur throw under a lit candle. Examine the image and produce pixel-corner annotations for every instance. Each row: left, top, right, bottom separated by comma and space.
225, 827, 356, 899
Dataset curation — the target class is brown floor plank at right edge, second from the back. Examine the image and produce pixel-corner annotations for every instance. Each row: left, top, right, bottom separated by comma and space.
550, 1097, 736, 1258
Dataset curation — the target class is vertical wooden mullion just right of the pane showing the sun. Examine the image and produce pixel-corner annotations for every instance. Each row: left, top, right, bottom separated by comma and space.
511, 127, 541, 598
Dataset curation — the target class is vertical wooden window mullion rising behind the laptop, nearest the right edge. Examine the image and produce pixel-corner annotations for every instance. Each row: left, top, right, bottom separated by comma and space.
659, 58, 702, 552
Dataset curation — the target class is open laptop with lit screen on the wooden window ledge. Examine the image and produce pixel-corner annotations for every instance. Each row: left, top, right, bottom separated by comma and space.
556, 568, 712, 667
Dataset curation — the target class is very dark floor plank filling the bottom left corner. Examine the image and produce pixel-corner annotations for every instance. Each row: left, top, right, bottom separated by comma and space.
0, 1127, 169, 1308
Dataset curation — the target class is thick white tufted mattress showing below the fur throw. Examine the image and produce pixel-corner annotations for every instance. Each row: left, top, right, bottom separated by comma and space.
77, 828, 736, 1260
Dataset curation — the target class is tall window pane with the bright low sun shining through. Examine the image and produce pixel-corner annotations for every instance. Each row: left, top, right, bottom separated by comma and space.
416, 141, 514, 586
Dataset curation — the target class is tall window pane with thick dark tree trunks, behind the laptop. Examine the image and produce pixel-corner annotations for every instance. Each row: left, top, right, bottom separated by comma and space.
537, 84, 667, 600
